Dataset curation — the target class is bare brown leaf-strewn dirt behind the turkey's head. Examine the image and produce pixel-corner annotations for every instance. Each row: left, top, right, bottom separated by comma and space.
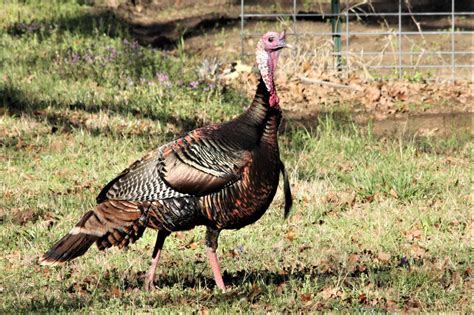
109, 0, 474, 135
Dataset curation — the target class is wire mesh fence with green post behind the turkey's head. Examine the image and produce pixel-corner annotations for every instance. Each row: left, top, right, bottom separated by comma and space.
240, 0, 474, 81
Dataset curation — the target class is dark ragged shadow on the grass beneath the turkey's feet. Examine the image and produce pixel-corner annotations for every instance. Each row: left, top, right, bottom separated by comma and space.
4, 266, 400, 313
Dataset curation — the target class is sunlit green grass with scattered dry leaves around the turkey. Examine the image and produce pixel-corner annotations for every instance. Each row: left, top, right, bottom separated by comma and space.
0, 1, 474, 313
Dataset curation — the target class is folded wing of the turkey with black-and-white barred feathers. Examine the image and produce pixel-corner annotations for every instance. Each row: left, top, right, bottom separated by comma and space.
97, 129, 250, 203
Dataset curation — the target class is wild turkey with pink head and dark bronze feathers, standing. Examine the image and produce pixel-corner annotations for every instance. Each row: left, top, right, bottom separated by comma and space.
40, 32, 292, 290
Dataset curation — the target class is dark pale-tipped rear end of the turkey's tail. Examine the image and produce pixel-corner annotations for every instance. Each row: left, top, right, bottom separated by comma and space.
40, 211, 105, 266
